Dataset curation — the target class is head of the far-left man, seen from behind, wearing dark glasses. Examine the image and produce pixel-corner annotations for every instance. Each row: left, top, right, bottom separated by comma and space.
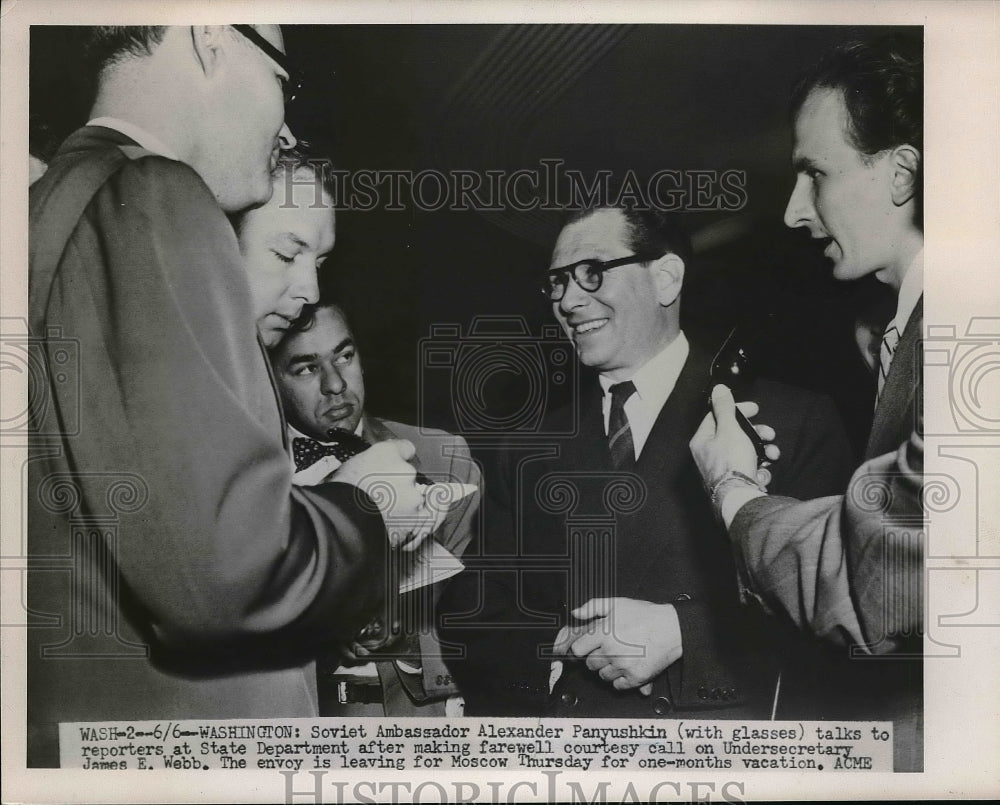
88, 25, 294, 212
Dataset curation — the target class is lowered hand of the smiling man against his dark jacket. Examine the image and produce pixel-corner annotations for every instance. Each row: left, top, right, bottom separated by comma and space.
553, 598, 682, 696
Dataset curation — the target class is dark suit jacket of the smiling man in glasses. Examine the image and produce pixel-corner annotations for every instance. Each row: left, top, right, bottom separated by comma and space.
438, 342, 850, 717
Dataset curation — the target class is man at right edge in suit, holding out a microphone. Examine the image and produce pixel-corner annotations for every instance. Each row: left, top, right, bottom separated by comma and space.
691, 34, 924, 770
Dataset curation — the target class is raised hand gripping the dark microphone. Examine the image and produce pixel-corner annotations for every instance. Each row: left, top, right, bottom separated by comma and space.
691, 384, 781, 487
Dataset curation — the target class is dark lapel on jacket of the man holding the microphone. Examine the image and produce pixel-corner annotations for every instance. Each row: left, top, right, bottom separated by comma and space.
865, 296, 924, 459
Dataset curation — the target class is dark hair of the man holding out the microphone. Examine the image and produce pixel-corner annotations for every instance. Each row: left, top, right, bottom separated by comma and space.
791, 34, 924, 160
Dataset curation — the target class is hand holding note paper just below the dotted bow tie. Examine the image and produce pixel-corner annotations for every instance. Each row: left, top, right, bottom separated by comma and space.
330, 439, 438, 551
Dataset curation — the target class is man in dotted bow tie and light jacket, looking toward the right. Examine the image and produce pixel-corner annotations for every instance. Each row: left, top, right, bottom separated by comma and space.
270, 304, 480, 716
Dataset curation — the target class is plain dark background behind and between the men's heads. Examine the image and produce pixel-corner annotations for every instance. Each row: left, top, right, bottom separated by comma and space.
30, 25, 916, 458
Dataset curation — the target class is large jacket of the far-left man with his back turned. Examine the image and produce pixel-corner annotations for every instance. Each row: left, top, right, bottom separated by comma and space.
27, 127, 387, 766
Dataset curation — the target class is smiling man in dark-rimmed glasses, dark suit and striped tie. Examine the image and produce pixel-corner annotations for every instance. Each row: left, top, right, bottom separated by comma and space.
438, 207, 849, 718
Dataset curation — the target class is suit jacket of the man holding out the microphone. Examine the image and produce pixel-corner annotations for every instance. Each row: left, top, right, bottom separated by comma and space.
730, 299, 925, 770
